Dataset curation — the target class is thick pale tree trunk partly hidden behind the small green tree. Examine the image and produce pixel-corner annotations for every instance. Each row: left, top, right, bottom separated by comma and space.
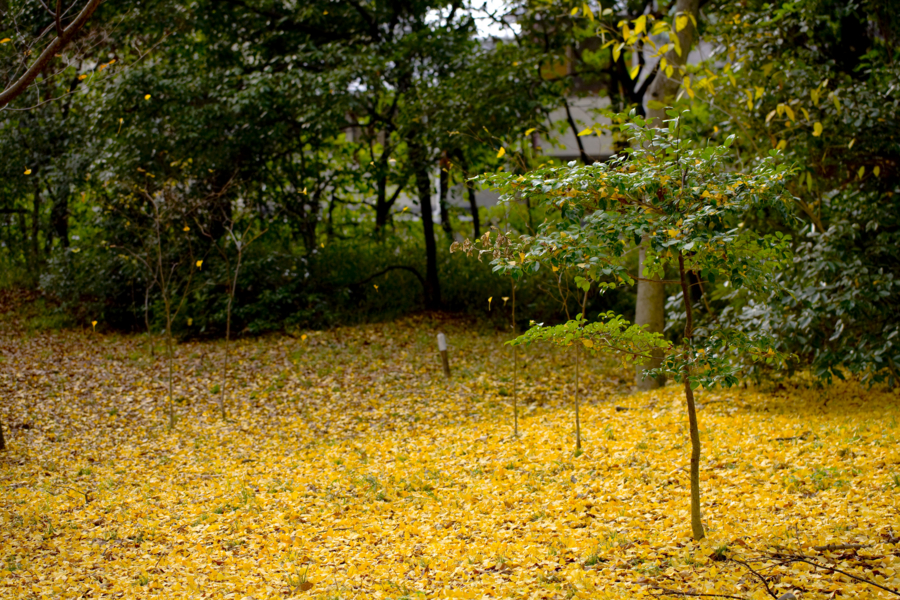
634, 0, 700, 390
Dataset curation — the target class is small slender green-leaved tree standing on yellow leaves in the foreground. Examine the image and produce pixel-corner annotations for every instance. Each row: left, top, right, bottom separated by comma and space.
454, 111, 792, 540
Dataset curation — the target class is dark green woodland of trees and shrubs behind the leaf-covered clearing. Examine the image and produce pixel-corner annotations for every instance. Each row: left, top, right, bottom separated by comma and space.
0, 0, 900, 381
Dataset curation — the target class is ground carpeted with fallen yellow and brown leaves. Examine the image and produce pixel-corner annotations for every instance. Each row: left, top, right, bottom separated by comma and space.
0, 304, 900, 599
